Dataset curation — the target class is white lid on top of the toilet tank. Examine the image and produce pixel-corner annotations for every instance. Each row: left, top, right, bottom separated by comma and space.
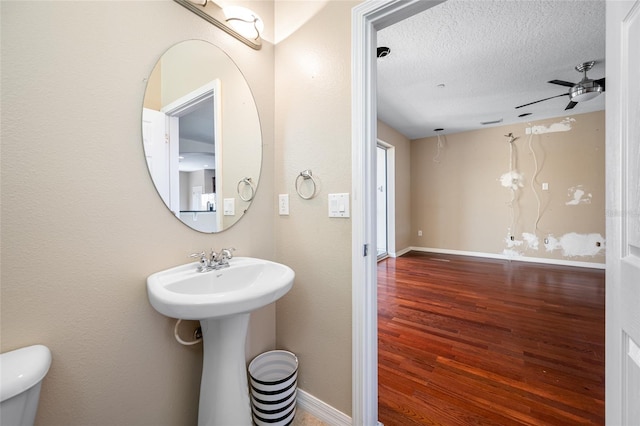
0, 345, 51, 402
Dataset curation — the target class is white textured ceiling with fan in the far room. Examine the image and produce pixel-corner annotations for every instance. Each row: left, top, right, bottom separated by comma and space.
378, 0, 606, 139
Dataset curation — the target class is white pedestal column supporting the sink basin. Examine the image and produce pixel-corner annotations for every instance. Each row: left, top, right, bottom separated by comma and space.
198, 313, 252, 426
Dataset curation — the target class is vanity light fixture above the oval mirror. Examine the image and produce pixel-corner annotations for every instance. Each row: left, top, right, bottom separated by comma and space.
174, 0, 264, 50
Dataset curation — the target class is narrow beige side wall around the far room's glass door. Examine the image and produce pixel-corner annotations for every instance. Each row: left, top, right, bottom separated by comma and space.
378, 120, 411, 254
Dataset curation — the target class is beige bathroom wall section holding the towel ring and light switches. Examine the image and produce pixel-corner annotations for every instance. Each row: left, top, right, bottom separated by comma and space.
274, 1, 358, 414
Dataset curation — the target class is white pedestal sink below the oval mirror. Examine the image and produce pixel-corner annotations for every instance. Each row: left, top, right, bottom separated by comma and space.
147, 257, 295, 426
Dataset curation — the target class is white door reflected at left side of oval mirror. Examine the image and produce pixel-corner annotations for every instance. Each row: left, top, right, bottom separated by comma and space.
142, 108, 170, 206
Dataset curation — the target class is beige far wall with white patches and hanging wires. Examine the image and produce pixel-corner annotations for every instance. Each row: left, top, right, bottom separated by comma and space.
411, 112, 606, 264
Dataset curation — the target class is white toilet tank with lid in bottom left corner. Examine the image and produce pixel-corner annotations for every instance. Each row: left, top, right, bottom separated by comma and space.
0, 345, 51, 426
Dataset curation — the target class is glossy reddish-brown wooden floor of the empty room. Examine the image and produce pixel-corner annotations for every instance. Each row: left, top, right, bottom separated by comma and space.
378, 252, 604, 426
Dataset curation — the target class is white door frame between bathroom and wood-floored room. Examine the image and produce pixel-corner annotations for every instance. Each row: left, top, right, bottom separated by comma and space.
351, 0, 444, 425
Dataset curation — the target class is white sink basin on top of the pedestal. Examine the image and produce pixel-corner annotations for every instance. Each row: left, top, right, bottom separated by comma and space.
147, 257, 295, 320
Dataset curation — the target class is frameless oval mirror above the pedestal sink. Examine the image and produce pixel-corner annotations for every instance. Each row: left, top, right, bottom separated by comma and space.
142, 40, 262, 232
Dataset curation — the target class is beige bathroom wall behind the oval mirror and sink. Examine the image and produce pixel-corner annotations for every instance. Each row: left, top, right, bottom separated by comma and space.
0, 1, 276, 426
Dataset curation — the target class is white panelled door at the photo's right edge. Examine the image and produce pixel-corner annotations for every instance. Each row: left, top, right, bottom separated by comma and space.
605, 1, 640, 425
